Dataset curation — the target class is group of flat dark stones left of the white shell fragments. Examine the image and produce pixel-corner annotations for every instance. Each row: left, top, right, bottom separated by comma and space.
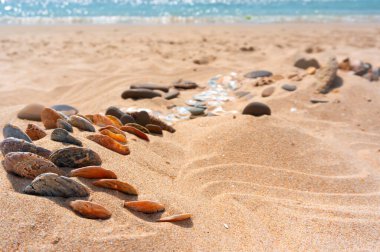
121, 79, 198, 100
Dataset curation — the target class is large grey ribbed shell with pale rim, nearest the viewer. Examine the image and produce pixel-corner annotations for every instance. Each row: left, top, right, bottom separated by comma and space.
24, 173, 89, 198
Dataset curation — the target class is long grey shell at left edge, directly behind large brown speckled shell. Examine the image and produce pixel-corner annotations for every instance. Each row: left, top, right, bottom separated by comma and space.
0, 137, 51, 158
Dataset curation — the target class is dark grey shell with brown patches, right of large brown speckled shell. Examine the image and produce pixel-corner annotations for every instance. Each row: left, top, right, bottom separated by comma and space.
49, 146, 102, 168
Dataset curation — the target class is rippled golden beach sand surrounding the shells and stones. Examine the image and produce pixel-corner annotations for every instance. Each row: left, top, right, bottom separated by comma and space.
0, 24, 380, 251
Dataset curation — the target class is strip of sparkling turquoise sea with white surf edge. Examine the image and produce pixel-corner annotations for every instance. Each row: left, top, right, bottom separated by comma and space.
0, 0, 380, 24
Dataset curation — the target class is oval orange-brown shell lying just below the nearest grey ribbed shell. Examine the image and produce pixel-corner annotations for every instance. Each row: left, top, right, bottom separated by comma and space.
70, 200, 112, 220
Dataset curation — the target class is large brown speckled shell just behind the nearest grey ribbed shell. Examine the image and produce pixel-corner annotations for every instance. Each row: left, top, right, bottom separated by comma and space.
2, 152, 62, 179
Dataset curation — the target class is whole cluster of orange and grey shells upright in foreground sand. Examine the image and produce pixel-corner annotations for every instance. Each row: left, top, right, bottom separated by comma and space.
0, 104, 191, 222
